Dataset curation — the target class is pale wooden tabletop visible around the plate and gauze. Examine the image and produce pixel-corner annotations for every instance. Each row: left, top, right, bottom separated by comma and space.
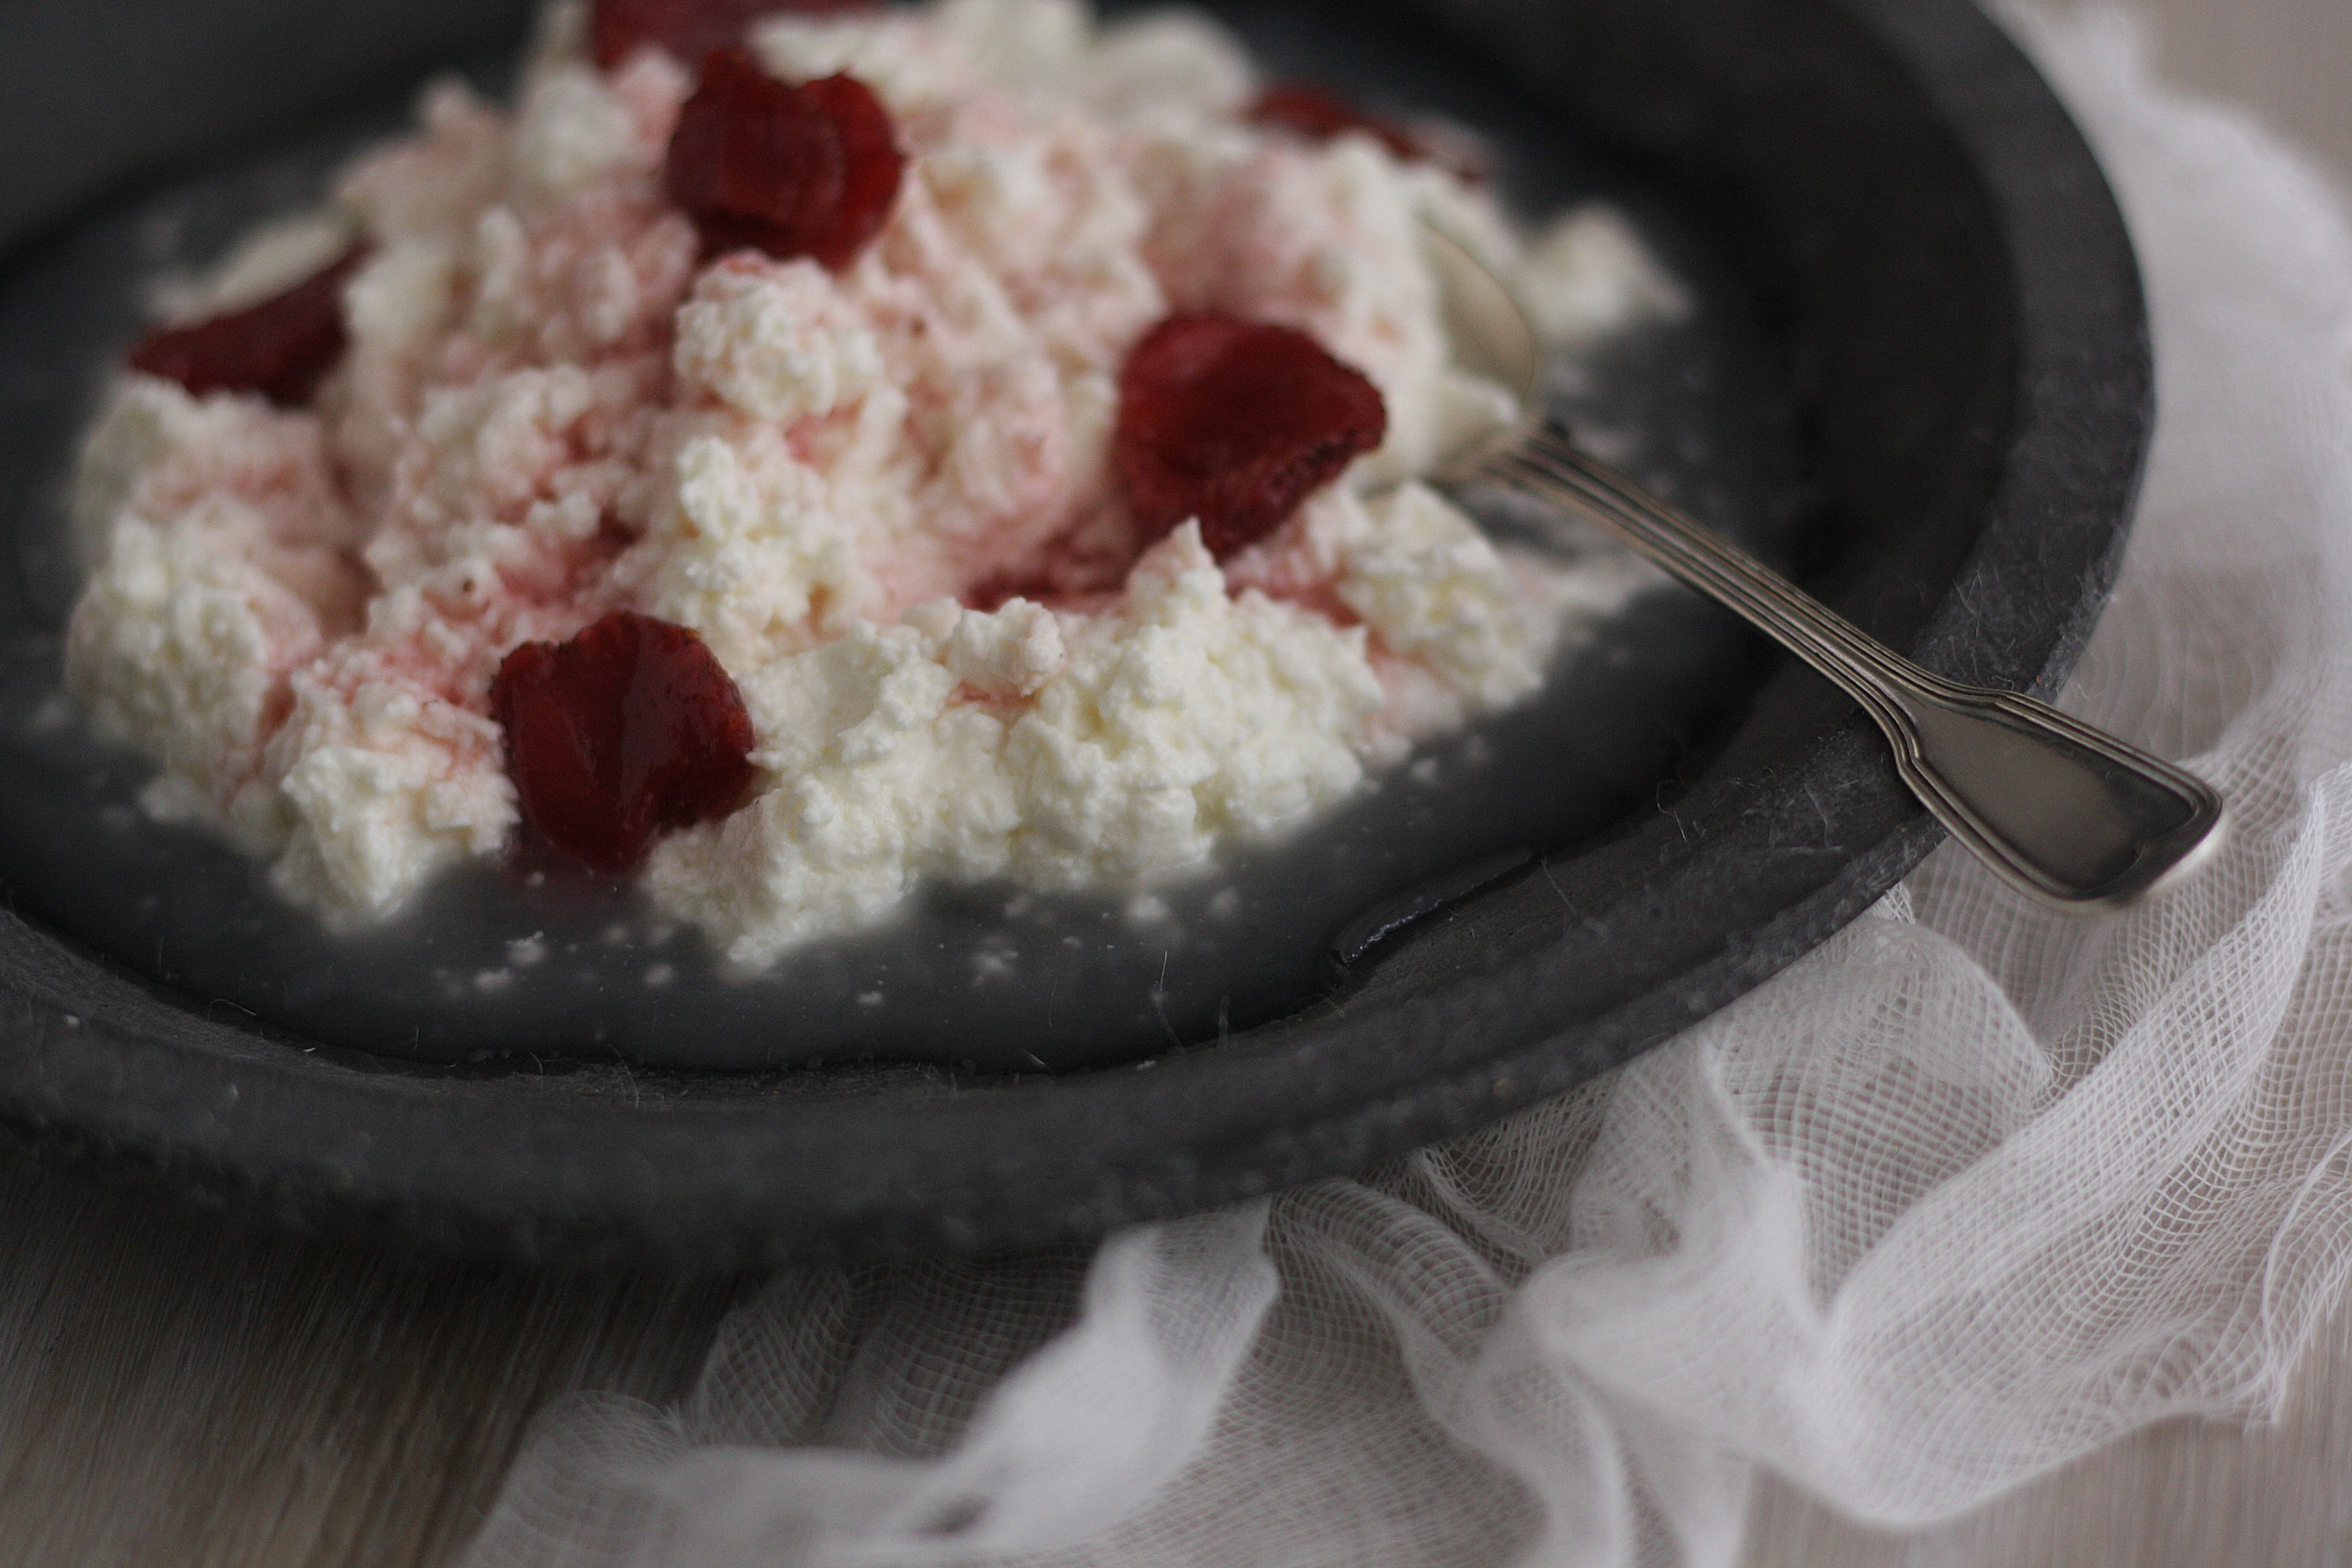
0, 0, 2352, 1568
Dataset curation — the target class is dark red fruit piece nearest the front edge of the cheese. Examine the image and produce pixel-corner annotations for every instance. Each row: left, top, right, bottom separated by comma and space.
489, 609, 755, 877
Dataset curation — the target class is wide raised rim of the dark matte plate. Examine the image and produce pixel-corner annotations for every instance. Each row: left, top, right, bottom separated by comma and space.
0, 0, 2150, 1267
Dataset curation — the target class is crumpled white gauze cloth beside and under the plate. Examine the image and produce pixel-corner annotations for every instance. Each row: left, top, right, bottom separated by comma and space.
449, 16, 2352, 1568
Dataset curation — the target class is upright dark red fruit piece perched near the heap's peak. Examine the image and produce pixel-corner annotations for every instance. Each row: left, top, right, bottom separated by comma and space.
663, 50, 906, 270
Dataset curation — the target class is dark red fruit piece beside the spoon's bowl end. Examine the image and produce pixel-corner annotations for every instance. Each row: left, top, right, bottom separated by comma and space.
1112, 310, 1388, 560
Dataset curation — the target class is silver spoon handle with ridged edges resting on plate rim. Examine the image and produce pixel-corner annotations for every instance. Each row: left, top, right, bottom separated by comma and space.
1477, 421, 2227, 912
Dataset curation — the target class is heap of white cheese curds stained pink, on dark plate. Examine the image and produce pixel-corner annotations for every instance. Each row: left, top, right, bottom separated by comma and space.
68, 0, 1679, 966
